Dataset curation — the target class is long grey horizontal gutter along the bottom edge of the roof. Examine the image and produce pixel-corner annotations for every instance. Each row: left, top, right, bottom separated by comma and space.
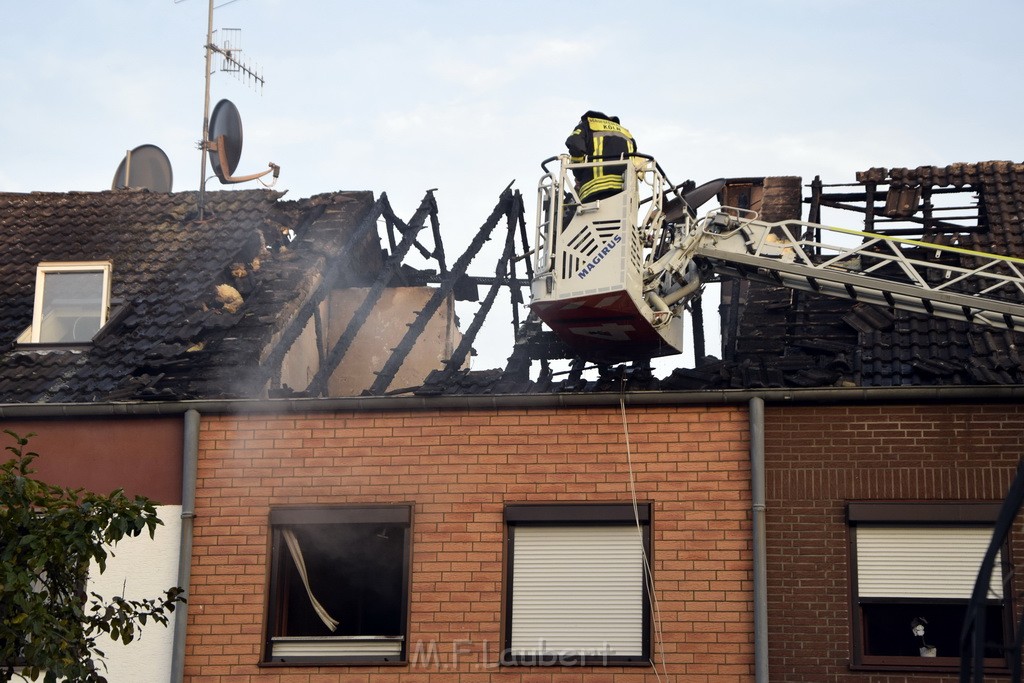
0, 385, 1024, 419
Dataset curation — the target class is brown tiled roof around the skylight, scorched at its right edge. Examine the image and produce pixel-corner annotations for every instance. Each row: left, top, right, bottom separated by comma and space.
0, 190, 381, 402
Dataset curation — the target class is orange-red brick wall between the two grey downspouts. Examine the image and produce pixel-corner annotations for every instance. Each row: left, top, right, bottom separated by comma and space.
185, 407, 753, 683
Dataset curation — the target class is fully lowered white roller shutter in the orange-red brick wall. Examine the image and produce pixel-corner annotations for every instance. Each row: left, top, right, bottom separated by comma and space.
511, 525, 644, 656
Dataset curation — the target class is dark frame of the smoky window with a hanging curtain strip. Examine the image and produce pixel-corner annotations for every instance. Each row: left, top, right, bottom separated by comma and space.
260, 504, 414, 667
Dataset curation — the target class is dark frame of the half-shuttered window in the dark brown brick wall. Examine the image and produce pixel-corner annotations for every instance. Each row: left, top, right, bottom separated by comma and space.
846, 501, 1016, 673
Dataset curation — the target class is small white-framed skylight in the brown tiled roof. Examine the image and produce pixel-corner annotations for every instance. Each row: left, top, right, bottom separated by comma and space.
20, 261, 112, 344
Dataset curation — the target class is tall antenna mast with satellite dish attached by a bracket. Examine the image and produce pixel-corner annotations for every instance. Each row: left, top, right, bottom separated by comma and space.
193, 0, 281, 220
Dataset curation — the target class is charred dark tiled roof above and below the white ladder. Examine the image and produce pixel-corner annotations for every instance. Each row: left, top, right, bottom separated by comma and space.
692, 161, 1024, 388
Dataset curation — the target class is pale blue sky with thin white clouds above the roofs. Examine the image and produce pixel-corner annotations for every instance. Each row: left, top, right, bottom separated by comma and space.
0, 0, 1024, 369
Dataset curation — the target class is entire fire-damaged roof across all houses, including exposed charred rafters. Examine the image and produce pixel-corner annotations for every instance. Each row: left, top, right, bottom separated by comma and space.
6, 162, 1024, 403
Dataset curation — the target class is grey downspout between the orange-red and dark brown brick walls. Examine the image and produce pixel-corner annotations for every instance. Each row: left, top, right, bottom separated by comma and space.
750, 397, 768, 683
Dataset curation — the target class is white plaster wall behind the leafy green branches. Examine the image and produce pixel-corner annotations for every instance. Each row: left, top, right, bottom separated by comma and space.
88, 505, 181, 683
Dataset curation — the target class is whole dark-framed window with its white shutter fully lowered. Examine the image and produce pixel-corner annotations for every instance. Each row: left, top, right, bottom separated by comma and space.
501, 504, 651, 667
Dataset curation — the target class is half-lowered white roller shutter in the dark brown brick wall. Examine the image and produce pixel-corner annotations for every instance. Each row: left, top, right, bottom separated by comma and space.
857, 524, 1002, 600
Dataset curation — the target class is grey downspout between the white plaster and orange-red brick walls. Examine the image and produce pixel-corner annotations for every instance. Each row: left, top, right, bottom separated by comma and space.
171, 410, 200, 683
